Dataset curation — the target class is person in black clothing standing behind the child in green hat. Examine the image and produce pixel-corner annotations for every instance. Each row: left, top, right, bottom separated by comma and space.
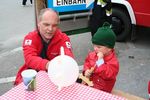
90, 0, 112, 36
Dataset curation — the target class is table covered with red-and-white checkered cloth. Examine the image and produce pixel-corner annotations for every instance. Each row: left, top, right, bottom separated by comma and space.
0, 71, 125, 100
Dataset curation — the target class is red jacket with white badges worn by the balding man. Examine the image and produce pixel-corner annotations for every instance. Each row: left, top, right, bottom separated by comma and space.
14, 29, 73, 85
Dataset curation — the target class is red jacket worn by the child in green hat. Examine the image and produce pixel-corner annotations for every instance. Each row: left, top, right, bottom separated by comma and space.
83, 50, 119, 92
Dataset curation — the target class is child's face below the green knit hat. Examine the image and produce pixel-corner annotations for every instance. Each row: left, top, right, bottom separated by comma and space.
93, 44, 111, 55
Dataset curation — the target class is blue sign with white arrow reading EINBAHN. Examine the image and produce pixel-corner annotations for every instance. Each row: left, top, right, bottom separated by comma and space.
48, 0, 94, 12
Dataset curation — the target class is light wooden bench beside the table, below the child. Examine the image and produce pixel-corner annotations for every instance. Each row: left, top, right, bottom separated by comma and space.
112, 89, 146, 100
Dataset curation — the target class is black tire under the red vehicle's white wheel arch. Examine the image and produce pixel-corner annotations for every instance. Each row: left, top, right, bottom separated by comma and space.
112, 8, 131, 42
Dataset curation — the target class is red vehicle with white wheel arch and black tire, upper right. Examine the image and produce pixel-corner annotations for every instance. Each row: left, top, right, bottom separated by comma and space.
112, 0, 150, 41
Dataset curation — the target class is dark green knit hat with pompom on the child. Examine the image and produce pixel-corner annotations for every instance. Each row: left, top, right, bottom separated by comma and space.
92, 22, 116, 48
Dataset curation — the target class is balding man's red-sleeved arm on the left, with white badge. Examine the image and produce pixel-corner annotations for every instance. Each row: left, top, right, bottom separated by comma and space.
23, 33, 48, 71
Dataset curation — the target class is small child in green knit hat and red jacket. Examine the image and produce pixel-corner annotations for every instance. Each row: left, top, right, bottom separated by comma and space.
83, 23, 119, 92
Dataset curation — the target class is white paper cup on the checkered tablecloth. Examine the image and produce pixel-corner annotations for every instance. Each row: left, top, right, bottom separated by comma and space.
21, 69, 37, 90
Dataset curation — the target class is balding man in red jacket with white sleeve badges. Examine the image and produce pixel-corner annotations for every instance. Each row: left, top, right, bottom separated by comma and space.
14, 8, 73, 85
